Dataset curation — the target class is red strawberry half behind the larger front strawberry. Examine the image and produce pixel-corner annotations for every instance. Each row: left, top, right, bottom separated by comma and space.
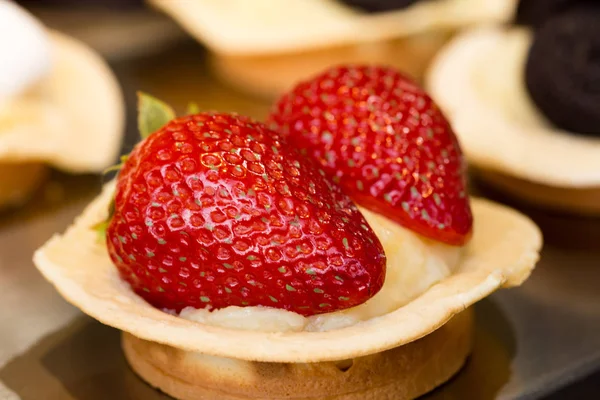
268, 66, 472, 245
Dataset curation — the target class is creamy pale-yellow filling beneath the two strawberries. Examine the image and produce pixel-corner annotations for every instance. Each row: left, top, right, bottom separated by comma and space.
180, 209, 462, 332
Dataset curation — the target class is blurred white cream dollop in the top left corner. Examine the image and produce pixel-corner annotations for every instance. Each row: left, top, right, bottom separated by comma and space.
0, 0, 52, 104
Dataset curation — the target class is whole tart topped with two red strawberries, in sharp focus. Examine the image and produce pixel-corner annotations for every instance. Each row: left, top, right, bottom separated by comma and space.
34, 66, 541, 400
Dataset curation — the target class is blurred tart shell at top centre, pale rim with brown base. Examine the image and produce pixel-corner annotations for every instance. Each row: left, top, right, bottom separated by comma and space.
150, 0, 517, 98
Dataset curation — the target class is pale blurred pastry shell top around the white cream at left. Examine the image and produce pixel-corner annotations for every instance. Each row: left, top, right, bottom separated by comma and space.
0, 31, 124, 172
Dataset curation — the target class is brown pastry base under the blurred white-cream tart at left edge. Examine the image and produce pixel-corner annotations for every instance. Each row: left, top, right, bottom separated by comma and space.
0, 163, 48, 209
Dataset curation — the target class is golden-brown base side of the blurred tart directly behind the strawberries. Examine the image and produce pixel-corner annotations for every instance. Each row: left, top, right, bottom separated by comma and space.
210, 30, 451, 98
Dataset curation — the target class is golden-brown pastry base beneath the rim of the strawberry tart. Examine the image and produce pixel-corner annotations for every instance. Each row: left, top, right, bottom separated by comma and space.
122, 308, 473, 400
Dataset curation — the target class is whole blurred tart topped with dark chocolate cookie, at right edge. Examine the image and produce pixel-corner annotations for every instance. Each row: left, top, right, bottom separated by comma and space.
428, 1, 600, 216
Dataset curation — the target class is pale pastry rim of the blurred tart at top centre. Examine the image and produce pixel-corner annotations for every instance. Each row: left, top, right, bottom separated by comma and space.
149, 0, 517, 55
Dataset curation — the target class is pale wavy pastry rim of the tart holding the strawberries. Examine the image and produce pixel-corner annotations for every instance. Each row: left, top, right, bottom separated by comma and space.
34, 184, 542, 362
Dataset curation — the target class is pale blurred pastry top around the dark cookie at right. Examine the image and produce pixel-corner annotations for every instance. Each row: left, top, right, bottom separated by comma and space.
427, 28, 600, 189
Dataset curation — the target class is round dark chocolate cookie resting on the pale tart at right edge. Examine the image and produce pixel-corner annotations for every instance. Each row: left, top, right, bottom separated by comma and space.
525, 4, 600, 135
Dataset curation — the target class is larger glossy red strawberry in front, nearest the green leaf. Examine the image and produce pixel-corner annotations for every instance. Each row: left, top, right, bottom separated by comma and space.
106, 95, 385, 316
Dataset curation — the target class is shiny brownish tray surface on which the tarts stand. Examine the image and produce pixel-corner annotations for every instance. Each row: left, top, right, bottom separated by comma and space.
0, 38, 600, 400
